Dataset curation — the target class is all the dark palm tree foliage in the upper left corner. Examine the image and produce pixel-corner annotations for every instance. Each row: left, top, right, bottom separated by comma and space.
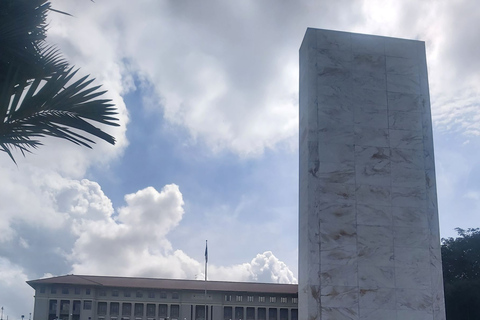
0, 0, 118, 162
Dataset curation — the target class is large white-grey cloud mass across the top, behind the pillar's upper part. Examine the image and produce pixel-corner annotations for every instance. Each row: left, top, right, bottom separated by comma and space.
50, 0, 480, 156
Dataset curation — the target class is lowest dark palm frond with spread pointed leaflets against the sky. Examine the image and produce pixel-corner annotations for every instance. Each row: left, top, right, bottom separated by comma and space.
0, 68, 118, 149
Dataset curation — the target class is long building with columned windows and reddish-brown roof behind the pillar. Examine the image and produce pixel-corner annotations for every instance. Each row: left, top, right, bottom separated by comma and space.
27, 275, 298, 320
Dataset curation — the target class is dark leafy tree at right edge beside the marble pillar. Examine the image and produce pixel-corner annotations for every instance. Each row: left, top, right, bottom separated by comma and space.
442, 228, 480, 320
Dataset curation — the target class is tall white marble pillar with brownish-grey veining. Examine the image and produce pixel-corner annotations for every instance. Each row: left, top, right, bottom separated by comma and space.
299, 29, 445, 320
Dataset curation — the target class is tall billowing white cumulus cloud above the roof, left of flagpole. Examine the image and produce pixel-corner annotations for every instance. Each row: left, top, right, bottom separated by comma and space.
69, 184, 184, 277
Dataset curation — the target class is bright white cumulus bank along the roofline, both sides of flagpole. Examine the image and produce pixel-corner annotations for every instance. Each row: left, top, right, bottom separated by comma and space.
69, 184, 296, 283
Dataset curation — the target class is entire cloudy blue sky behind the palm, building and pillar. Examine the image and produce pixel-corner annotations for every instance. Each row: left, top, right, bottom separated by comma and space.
0, 0, 480, 320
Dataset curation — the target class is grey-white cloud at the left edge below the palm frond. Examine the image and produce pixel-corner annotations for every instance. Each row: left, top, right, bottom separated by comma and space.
0, 159, 113, 276
